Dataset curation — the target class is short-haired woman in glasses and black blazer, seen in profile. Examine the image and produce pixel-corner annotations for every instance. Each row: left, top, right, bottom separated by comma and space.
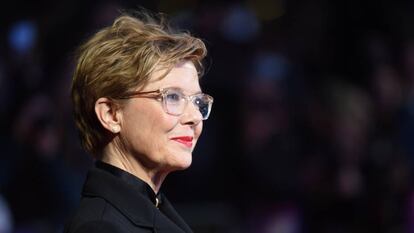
65, 10, 213, 233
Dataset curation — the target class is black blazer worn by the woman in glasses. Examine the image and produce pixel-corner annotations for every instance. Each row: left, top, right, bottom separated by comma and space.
64, 162, 192, 233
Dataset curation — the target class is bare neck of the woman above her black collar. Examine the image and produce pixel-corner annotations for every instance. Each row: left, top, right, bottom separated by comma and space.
101, 143, 168, 193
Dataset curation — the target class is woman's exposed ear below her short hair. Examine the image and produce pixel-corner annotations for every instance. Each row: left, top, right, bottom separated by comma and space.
95, 97, 121, 133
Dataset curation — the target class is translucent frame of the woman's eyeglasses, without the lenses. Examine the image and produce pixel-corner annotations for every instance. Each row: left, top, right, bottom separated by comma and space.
119, 87, 214, 120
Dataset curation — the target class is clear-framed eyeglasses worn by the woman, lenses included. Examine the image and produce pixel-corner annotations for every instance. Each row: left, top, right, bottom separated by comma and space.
120, 87, 214, 120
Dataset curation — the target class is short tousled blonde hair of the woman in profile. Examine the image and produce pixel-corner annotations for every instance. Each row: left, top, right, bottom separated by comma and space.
71, 10, 207, 157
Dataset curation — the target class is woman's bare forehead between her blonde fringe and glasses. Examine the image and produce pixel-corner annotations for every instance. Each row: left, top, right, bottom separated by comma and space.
145, 61, 200, 93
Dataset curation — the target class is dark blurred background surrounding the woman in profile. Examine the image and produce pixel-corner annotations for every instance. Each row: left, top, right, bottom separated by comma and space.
0, 0, 414, 233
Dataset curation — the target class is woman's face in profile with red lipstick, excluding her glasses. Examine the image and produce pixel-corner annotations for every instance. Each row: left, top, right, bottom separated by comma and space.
120, 61, 203, 171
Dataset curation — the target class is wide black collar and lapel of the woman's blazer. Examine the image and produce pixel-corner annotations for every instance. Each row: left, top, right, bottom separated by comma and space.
82, 162, 192, 232
